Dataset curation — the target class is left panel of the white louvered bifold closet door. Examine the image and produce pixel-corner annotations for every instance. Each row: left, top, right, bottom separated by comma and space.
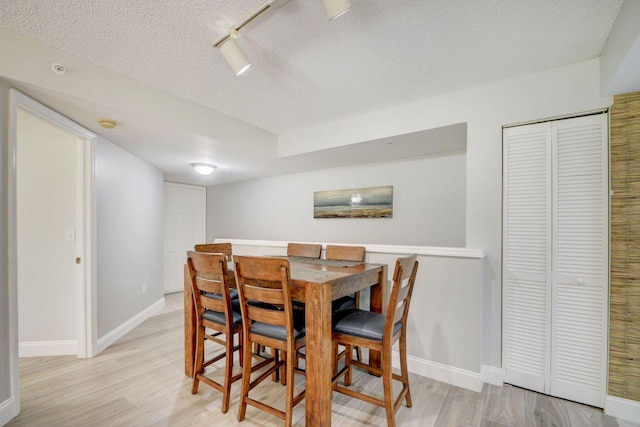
502, 123, 551, 393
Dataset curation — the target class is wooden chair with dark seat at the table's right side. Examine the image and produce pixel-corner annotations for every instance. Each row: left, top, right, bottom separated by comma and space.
333, 255, 418, 427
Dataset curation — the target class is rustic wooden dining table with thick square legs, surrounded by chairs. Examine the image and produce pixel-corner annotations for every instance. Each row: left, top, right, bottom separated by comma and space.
184, 257, 389, 427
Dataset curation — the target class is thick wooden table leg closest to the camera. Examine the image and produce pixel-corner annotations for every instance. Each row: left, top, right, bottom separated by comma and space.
305, 283, 333, 427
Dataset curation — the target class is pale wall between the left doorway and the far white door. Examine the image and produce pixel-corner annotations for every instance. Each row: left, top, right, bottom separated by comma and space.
96, 138, 163, 339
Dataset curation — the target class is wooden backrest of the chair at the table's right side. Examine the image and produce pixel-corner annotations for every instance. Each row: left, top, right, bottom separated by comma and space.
384, 255, 418, 338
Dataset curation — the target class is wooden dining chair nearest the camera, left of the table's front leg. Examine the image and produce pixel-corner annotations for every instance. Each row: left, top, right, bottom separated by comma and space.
235, 256, 306, 427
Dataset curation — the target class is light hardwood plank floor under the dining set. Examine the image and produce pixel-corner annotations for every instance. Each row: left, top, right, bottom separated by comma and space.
8, 293, 618, 427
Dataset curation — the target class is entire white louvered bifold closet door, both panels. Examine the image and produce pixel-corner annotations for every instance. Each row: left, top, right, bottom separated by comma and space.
502, 114, 609, 407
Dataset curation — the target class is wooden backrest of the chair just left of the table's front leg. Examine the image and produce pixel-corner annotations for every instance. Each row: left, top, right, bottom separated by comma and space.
235, 256, 293, 336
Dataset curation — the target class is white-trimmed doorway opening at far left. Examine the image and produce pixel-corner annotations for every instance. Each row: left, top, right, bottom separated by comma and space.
8, 89, 97, 410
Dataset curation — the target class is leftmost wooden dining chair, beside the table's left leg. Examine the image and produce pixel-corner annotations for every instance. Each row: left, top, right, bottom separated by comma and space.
187, 251, 245, 413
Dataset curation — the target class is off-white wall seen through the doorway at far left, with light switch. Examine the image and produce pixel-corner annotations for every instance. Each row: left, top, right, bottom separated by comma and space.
16, 110, 78, 355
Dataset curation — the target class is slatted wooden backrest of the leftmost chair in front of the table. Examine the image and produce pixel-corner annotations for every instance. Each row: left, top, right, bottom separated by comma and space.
187, 251, 233, 325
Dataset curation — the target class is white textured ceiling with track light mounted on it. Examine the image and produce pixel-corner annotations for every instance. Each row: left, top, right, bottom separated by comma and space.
0, 0, 622, 184
